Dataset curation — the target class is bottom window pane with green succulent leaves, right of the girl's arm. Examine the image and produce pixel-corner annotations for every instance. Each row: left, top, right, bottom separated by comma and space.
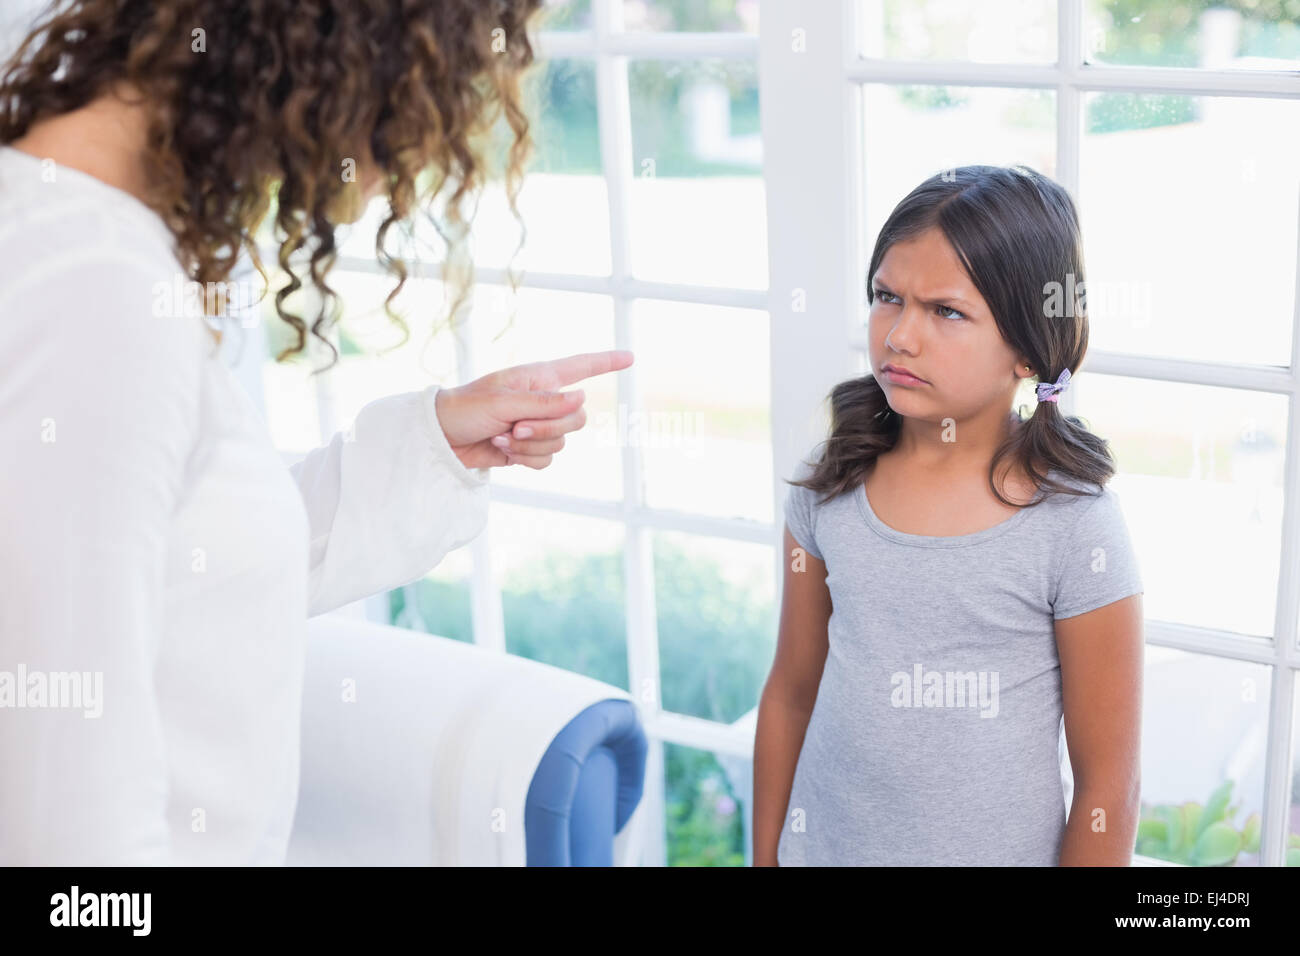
1136, 645, 1271, 866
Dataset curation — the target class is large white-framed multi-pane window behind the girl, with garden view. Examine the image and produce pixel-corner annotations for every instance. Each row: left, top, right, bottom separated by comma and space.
250, 0, 1300, 865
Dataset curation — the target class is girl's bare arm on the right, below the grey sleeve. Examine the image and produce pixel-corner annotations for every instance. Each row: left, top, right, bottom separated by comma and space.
1056, 594, 1143, 866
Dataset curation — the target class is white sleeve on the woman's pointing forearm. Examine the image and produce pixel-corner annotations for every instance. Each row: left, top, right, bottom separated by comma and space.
290, 385, 488, 615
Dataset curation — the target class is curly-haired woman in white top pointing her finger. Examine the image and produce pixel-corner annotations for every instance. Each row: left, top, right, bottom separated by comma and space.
0, 0, 632, 865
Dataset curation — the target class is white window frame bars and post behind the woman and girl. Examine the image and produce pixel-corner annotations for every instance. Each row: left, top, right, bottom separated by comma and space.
261, 0, 1300, 866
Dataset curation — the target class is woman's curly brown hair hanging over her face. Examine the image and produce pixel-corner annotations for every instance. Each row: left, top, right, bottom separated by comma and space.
0, 0, 542, 371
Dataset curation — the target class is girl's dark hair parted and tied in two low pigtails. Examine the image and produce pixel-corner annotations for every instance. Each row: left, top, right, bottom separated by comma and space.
789, 165, 1115, 507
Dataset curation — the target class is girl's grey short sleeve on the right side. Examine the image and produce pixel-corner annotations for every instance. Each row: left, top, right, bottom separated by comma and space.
1052, 488, 1143, 620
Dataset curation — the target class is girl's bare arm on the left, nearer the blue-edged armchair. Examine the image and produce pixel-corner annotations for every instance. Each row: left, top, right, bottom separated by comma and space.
754, 527, 831, 866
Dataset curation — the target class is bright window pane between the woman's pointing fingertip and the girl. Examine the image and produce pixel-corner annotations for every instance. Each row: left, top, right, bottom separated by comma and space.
631, 299, 772, 522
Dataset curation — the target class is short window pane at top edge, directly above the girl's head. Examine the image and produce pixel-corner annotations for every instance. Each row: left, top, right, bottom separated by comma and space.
858, 0, 1057, 62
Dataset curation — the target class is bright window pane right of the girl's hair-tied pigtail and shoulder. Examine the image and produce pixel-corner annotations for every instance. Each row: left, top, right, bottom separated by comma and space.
1070, 374, 1287, 637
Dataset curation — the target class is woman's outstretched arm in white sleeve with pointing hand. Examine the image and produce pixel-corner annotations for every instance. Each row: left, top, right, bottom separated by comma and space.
290, 350, 632, 615
